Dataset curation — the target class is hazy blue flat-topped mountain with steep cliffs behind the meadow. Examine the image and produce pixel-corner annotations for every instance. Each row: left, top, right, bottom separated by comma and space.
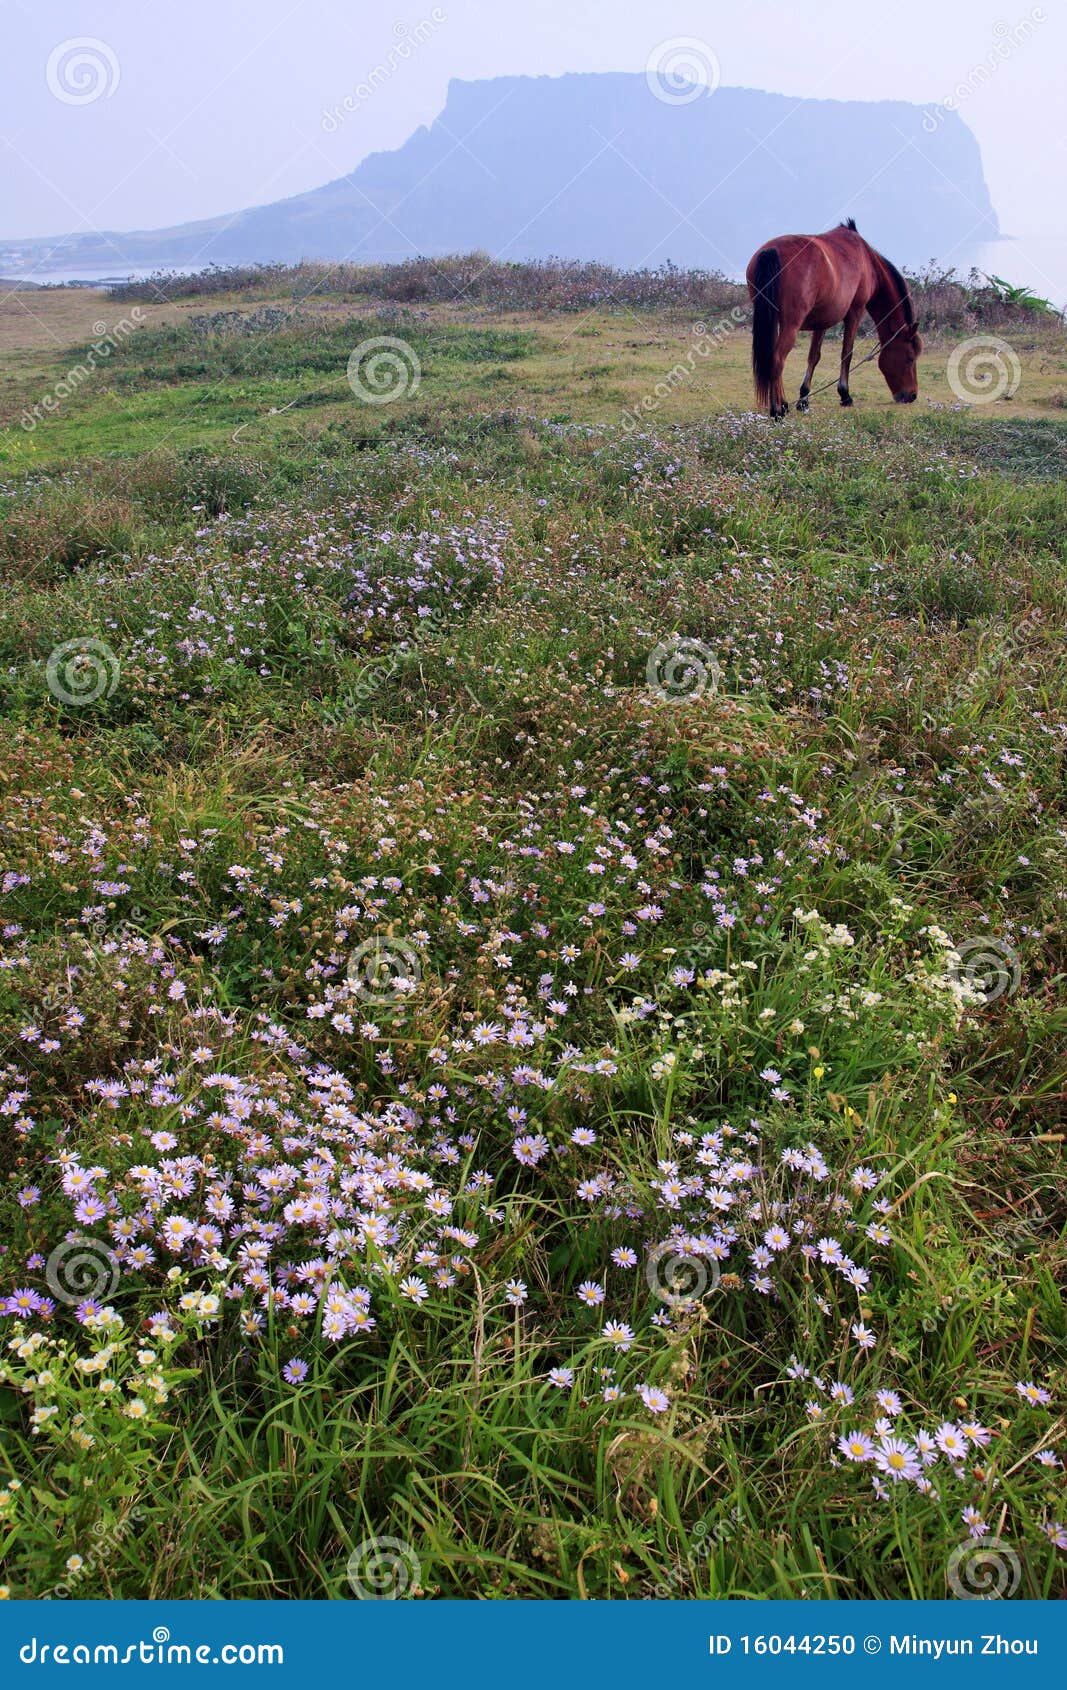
12, 74, 999, 272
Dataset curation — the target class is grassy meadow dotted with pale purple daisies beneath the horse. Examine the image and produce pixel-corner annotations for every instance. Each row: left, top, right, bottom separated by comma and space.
0, 272, 1067, 1600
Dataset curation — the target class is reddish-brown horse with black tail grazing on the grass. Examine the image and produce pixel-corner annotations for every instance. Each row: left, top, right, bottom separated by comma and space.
746, 218, 923, 417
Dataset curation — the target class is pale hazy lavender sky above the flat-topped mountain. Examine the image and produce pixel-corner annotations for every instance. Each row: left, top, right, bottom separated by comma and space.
0, 0, 1067, 240
